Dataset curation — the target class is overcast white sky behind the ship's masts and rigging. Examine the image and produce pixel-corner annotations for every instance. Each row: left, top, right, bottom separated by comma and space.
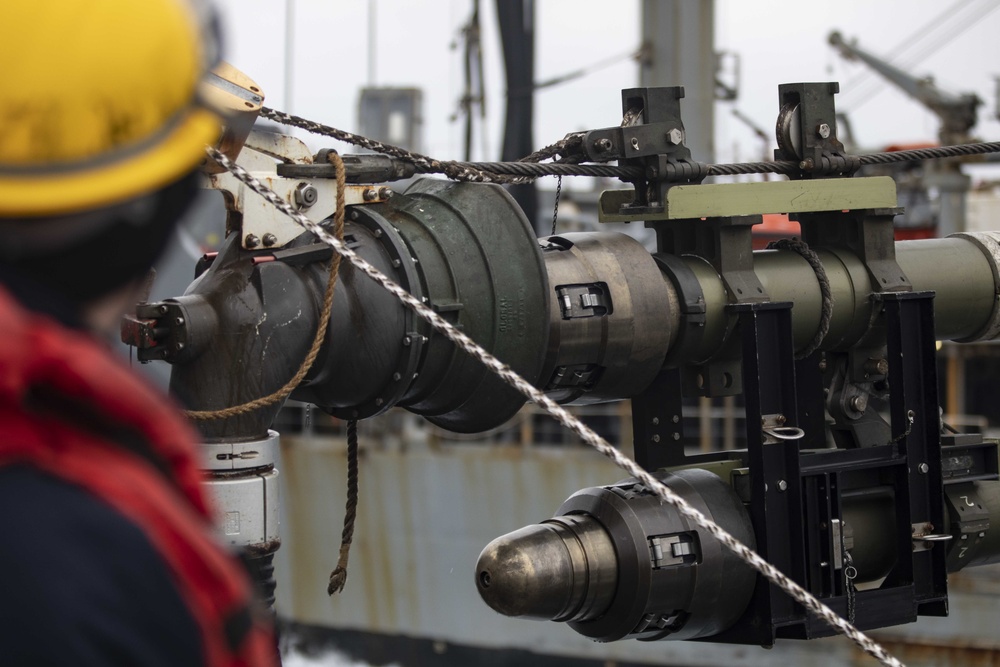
217, 0, 1000, 180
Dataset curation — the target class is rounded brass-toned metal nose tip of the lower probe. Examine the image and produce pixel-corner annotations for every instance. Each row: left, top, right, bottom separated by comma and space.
476, 514, 618, 621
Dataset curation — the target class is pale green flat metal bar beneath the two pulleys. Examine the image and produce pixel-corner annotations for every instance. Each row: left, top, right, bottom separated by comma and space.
598, 176, 896, 222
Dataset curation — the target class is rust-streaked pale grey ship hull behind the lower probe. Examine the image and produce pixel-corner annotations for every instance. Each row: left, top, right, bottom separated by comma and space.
276, 431, 1000, 667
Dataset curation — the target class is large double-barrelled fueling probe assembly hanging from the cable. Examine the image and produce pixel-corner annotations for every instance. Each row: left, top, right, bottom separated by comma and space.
125, 78, 1000, 645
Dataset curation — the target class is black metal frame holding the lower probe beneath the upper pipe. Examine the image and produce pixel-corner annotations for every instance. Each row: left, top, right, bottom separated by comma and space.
633, 292, 947, 645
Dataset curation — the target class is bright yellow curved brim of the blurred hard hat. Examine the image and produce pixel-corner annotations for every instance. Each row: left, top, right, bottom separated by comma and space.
0, 106, 222, 218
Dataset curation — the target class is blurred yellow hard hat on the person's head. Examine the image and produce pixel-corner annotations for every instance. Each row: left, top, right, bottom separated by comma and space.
0, 0, 220, 218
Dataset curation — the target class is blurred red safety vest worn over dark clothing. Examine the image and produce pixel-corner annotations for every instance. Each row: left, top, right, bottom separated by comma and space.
0, 290, 276, 667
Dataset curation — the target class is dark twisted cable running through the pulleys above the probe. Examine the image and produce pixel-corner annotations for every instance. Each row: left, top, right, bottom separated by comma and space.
260, 107, 1000, 183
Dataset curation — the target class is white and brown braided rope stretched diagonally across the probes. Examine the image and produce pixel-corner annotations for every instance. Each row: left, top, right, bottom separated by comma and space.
207, 147, 903, 667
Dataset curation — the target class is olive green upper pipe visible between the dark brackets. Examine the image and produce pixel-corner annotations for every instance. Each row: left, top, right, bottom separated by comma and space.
675, 238, 997, 361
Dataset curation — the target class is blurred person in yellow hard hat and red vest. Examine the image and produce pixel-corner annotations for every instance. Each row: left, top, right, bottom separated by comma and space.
0, 0, 277, 667
